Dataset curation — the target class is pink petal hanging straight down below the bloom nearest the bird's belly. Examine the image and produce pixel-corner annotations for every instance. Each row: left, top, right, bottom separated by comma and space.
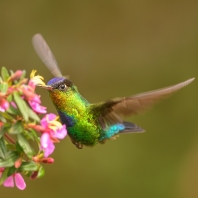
41, 133, 55, 157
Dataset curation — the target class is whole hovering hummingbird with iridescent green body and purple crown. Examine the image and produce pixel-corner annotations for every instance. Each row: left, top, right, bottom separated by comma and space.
32, 34, 194, 149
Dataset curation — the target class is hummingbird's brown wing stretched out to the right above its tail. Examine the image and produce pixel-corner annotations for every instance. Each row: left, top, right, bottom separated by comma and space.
90, 78, 194, 128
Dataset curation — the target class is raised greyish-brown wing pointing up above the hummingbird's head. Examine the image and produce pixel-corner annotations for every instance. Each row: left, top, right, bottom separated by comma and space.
32, 34, 62, 77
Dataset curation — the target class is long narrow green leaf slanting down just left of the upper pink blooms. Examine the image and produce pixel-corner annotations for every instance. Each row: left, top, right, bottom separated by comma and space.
13, 92, 29, 121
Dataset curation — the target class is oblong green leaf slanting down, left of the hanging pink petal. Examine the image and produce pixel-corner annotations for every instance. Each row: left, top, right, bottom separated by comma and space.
17, 134, 34, 158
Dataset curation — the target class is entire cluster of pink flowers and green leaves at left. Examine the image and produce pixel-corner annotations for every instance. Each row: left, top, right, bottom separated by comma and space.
0, 67, 67, 190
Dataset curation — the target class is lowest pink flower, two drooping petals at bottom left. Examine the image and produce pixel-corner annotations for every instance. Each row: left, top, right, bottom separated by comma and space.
0, 168, 26, 190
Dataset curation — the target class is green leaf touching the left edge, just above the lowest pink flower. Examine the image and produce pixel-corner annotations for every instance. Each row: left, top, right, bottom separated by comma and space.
0, 151, 19, 167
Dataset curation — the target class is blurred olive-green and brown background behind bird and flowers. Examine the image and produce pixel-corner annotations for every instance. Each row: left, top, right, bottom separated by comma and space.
0, 0, 198, 198
